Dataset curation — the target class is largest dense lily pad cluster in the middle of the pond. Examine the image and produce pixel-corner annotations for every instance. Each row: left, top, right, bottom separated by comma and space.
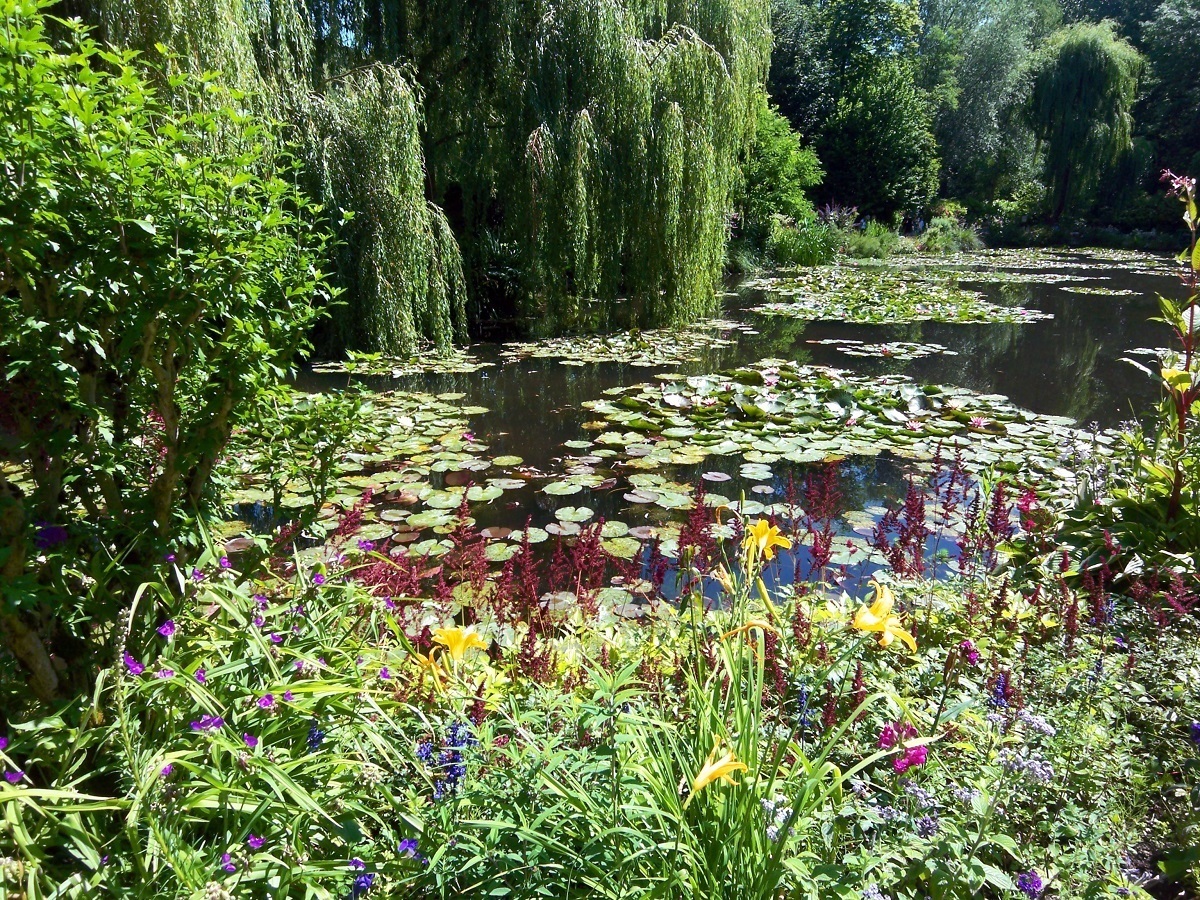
573, 359, 1114, 493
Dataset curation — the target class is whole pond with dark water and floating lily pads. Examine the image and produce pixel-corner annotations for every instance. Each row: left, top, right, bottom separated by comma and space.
260, 251, 1182, 595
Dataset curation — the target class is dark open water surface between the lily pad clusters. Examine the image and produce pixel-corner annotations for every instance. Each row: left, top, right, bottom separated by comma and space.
292, 256, 1182, 585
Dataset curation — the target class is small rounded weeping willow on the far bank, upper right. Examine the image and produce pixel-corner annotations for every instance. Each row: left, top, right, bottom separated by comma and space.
1028, 22, 1144, 222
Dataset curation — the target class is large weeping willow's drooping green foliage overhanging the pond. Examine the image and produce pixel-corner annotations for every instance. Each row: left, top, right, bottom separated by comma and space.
68, 0, 770, 350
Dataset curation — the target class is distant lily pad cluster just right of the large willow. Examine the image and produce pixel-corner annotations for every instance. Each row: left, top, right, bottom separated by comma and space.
745, 265, 1051, 324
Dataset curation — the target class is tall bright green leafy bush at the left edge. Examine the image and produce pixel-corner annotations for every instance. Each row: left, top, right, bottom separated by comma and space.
0, 0, 328, 697
